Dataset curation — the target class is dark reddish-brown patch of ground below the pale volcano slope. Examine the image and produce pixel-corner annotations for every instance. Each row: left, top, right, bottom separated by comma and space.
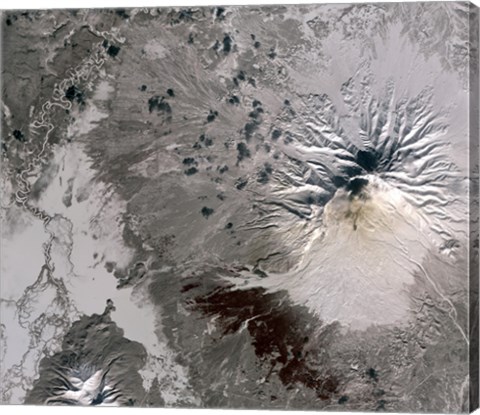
182, 283, 339, 400
